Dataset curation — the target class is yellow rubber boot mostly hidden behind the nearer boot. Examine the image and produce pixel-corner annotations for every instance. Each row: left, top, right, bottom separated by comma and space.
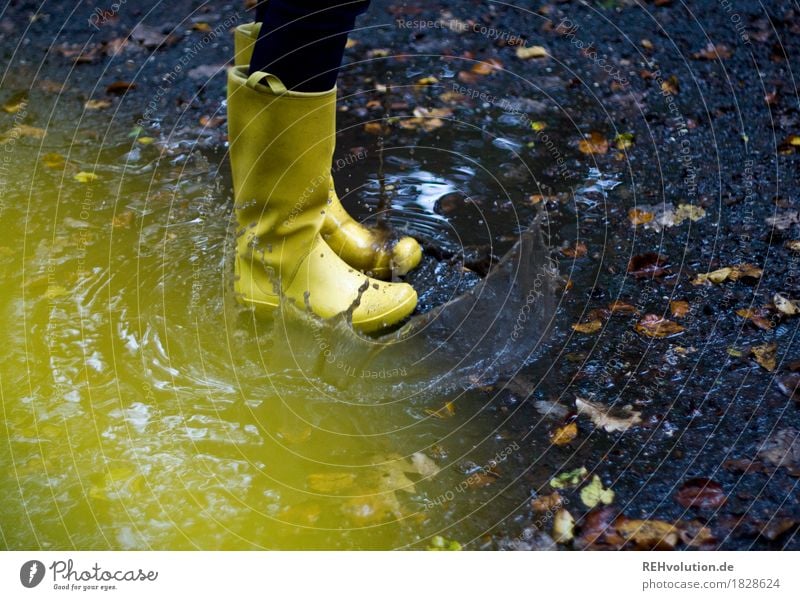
234, 23, 422, 279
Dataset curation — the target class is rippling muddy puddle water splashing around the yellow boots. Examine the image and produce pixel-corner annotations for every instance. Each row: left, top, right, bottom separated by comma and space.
0, 83, 620, 549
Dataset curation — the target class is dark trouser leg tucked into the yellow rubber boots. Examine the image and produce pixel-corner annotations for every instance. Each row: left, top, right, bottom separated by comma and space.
250, 0, 369, 92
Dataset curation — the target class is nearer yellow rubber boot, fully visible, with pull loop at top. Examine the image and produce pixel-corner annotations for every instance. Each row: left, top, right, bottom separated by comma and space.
228, 67, 417, 332
